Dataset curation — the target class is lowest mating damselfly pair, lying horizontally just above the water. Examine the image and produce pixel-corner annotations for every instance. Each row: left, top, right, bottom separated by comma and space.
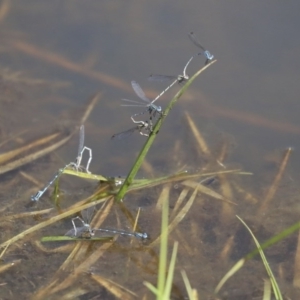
65, 207, 148, 240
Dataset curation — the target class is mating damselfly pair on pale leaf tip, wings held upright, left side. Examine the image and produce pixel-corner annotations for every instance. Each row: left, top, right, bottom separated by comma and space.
31, 125, 92, 201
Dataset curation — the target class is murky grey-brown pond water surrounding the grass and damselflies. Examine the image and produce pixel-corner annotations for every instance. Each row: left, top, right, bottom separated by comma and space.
0, 1, 300, 299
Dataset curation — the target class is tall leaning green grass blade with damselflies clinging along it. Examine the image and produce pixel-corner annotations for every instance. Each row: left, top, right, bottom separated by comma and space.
116, 60, 216, 201
